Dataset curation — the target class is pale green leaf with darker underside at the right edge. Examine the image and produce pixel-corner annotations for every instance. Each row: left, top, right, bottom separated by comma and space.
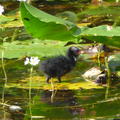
80, 25, 120, 48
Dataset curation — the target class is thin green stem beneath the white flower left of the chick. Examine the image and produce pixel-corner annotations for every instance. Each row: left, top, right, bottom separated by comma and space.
29, 66, 33, 120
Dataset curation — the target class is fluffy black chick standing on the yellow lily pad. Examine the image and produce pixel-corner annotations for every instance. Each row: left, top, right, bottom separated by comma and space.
39, 47, 82, 83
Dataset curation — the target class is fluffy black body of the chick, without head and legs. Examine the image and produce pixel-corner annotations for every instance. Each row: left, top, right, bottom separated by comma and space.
40, 56, 75, 77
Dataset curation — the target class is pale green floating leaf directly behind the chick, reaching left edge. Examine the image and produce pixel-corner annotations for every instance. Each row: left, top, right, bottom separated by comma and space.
0, 39, 67, 59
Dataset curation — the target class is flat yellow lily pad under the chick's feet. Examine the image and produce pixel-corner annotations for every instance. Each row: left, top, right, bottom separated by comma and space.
7, 76, 102, 90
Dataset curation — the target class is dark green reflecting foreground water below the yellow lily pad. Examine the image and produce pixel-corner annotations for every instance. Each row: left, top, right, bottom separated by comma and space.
0, 88, 120, 120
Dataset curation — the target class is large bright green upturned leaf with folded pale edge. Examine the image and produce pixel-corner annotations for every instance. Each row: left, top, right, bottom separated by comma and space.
20, 2, 80, 40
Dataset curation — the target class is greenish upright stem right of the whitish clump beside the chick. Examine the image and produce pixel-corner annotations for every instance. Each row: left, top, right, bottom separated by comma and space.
105, 57, 111, 99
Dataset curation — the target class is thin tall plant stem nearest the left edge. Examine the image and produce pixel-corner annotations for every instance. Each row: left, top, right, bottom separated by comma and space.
1, 50, 7, 120
